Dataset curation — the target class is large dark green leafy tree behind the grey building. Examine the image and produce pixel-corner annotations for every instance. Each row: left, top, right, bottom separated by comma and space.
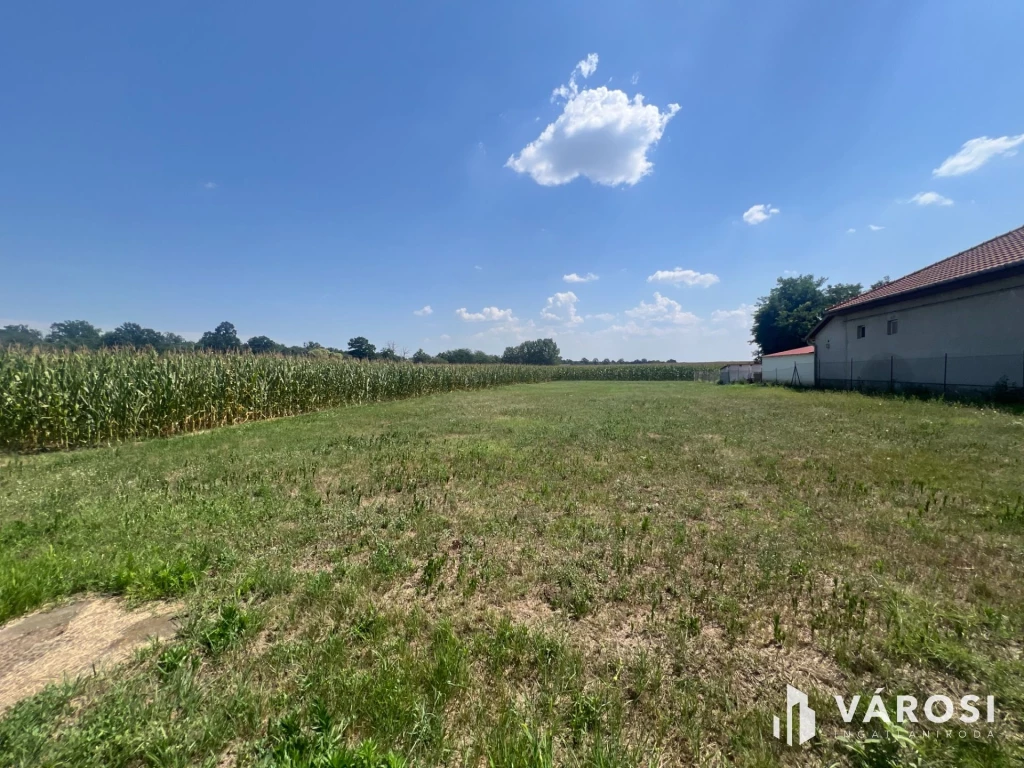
752, 274, 863, 354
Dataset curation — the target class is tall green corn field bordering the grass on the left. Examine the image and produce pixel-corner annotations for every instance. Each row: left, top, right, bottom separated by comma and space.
0, 348, 720, 452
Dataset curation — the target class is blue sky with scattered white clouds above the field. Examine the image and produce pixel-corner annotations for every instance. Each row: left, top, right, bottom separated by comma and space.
0, 0, 1024, 360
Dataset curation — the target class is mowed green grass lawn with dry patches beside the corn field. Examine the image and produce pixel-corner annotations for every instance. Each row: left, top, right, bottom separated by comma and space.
0, 382, 1024, 768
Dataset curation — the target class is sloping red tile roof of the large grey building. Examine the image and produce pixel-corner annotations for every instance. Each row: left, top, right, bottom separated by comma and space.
826, 226, 1024, 314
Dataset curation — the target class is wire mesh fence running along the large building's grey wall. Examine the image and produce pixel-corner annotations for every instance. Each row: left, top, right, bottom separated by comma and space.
815, 351, 1024, 396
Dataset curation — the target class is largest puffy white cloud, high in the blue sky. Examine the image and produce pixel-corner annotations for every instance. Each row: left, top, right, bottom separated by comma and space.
505, 53, 679, 186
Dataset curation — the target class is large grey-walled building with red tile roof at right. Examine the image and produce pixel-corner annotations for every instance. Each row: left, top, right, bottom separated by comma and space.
809, 222, 1024, 391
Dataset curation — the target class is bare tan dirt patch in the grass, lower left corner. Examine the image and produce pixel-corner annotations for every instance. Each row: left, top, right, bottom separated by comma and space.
0, 598, 180, 713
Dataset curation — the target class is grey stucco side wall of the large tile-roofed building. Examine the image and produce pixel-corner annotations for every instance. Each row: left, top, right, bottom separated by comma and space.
814, 275, 1024, 386
